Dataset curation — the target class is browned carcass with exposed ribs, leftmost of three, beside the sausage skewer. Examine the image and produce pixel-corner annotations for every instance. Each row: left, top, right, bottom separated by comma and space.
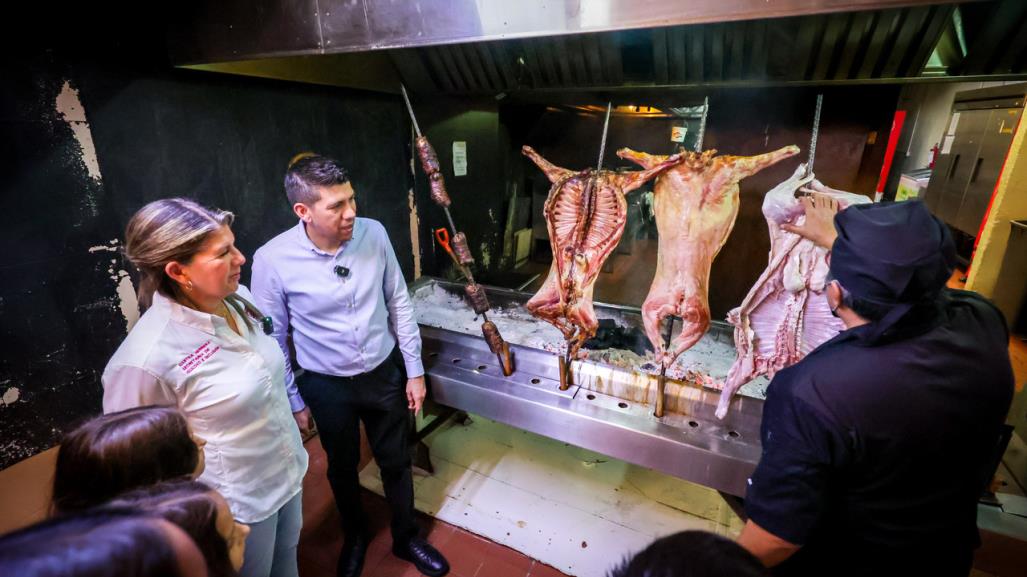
522, 146, 681, 357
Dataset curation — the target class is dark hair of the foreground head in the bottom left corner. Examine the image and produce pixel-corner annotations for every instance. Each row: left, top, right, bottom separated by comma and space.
0, 509, 188, 577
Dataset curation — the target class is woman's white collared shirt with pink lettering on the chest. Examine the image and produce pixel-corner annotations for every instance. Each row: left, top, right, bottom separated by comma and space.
103, 285, 307, 524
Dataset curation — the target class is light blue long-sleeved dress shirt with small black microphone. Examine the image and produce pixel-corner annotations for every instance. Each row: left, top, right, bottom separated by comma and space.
251, 218, 424, 412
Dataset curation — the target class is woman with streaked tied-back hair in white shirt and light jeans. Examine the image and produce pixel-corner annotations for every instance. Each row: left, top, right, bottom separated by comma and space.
103, 198, 307, 577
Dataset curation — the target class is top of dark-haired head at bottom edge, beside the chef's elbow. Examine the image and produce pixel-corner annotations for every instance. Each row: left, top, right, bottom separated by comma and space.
609, 531, 770, 577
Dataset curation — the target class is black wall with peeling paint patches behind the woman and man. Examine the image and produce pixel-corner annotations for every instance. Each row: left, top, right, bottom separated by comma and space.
0, 50, 414, 468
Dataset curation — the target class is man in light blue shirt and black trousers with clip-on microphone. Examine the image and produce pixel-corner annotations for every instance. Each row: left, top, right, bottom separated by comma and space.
251, 154, 449, 577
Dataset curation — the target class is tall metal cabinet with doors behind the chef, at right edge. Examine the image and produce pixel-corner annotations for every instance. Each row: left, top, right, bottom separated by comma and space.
924, 84, 1027, 236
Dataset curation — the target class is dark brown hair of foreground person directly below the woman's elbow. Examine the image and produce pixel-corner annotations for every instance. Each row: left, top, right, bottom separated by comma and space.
51, 407, 201, 514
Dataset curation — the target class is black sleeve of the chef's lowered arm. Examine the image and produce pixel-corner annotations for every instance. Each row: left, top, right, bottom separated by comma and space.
746, 367, 850, 545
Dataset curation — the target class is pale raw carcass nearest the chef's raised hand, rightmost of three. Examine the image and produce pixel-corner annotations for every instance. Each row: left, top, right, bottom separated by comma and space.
717, 164, 870, 419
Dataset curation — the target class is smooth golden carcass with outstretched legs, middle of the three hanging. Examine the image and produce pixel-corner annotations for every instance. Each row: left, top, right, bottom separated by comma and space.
617, 146, 799, 367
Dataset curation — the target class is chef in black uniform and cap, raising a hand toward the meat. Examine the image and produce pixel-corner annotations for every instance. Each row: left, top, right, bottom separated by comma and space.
738, 198, 1014, 577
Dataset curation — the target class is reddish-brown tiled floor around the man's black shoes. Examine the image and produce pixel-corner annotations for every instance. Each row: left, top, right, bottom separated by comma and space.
299, 437, 564, 577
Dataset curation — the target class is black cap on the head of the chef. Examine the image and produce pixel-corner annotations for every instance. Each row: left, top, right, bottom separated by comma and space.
831, 200, 956, 306
